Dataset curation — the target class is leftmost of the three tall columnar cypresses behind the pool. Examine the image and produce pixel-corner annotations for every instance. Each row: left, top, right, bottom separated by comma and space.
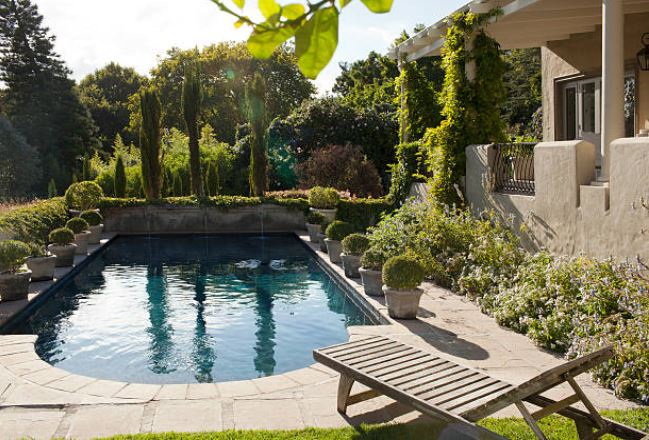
140, 89, 162, 200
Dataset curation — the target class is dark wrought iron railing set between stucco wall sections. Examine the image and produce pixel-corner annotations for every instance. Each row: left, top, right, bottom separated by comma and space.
492, 143, 536, 195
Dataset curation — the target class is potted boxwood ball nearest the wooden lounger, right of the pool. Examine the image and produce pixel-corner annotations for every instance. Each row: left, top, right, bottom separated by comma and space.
383, 255, 425, 319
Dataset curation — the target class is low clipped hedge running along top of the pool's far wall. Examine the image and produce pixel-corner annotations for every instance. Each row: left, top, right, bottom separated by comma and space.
99, 196, 309, 213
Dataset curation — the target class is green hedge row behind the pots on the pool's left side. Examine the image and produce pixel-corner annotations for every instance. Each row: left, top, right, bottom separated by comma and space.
0, 197, 70, 243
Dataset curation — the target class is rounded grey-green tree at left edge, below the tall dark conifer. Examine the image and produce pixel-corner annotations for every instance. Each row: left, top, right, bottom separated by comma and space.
0, 115, 40, 197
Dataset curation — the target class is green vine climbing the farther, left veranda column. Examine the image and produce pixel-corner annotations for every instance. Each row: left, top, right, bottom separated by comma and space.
396, 63, 441, 143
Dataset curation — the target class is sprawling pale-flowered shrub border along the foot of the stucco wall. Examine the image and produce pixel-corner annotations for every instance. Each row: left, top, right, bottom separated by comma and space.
366, 203, 649, 404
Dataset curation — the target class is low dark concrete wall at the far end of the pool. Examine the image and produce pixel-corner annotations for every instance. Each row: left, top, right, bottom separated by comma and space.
104, 204, 305, 234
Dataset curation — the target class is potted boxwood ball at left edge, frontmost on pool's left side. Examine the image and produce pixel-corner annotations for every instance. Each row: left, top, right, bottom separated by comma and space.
0, 240, 32, 302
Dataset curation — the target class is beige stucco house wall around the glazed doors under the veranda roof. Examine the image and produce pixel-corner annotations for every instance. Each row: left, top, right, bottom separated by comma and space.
541, 13, 649, 142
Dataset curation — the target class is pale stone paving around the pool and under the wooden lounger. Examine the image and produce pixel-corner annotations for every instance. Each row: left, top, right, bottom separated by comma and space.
0, 232, 634, 440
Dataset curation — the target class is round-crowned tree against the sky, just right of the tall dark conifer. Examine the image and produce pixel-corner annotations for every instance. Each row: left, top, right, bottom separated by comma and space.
79, 63, 146, 152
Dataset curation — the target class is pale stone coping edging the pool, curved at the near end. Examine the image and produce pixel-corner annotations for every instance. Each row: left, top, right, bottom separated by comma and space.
0, 231, 395, 408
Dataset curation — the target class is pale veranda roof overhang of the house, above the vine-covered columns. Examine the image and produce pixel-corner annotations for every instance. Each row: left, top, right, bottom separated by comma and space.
389, 0, 649, 61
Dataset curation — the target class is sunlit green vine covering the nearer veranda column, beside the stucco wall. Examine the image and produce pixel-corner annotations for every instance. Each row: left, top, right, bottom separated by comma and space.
424, 10, 505, 205
